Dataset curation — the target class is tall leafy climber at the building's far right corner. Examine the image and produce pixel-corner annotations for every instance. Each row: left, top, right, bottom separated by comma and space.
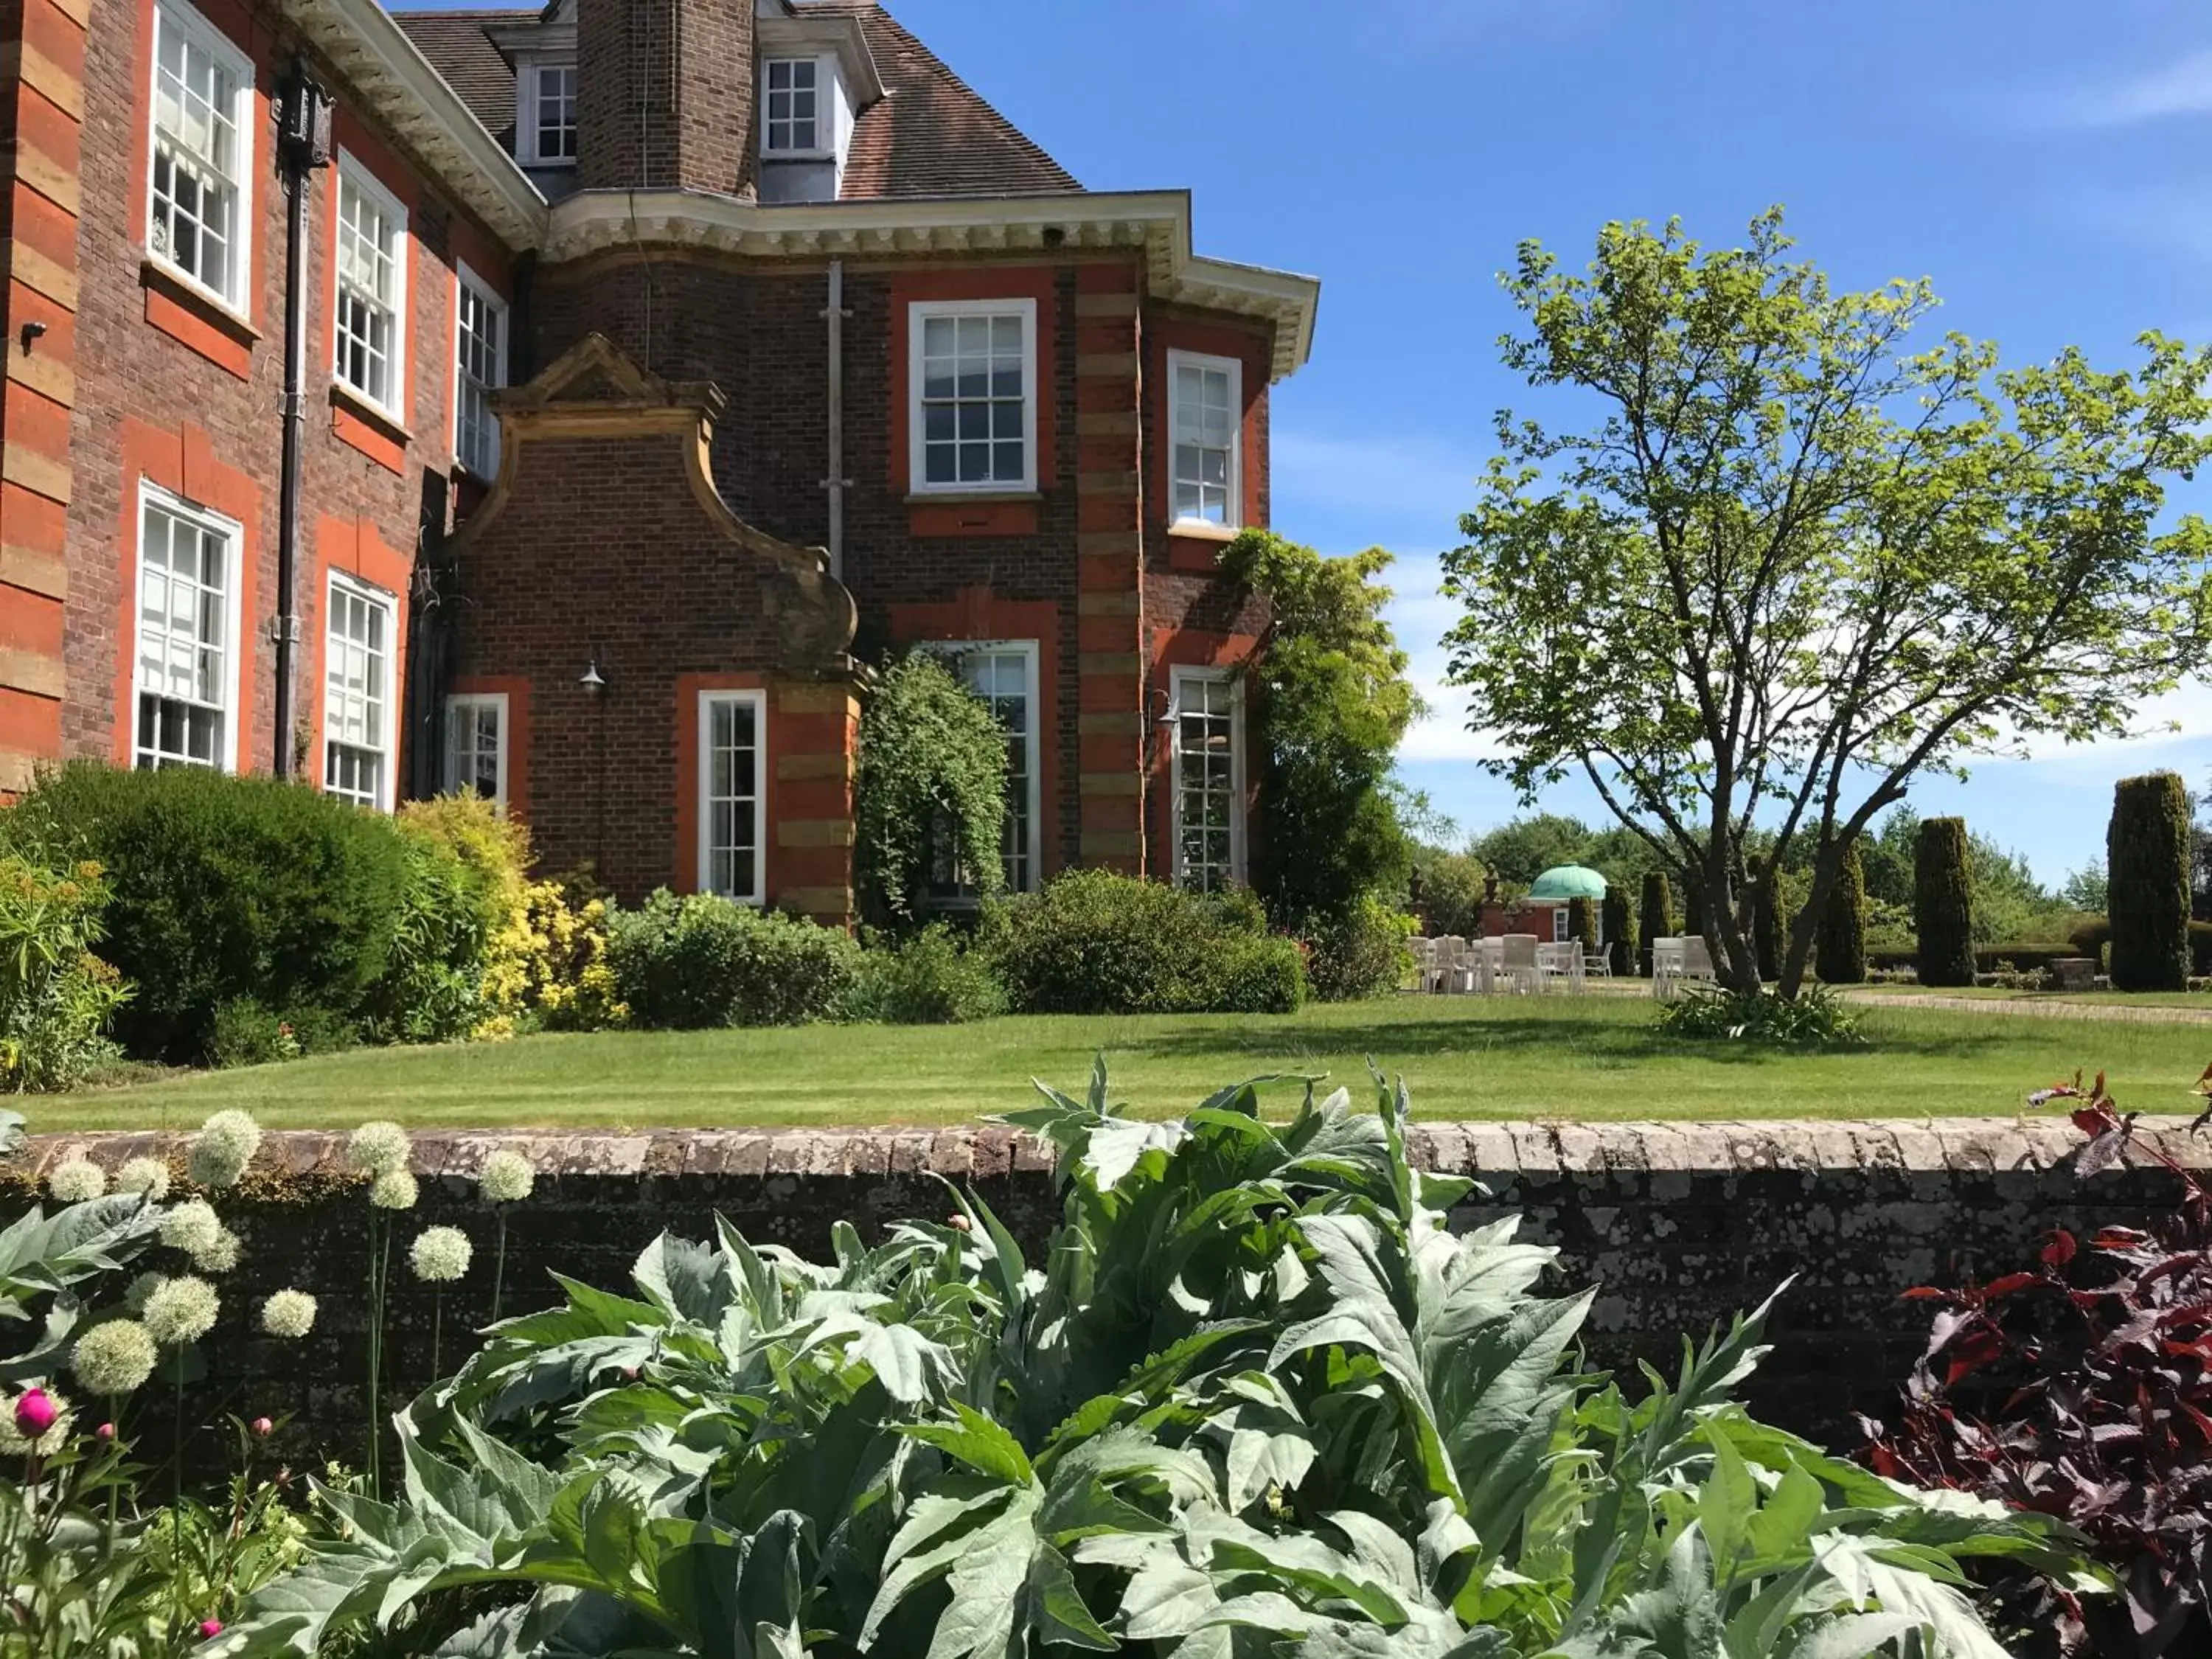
1221, 531, 1420, 929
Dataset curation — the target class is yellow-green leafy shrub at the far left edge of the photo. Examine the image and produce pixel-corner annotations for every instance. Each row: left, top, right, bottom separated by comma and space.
0, 854, 131, 1095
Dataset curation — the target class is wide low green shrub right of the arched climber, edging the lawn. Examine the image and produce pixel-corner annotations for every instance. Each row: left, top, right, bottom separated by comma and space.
984, 869, 1305, 1013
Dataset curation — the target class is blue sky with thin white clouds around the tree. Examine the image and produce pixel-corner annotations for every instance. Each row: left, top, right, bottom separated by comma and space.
889, 0, 2212, 883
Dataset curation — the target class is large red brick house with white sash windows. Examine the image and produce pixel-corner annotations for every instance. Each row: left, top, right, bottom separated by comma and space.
0, 0, 1318, 918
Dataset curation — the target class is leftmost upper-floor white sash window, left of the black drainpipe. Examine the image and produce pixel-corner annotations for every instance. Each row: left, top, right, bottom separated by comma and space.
146, 0, 254, 310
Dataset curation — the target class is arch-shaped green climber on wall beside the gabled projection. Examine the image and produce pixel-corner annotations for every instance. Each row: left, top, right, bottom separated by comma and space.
854, 650, 1006, 927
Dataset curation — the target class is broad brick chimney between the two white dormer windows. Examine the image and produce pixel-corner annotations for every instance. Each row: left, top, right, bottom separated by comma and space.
575, 0, 757, 195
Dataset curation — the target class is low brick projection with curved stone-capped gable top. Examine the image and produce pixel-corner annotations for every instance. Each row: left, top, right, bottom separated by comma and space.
451, 334, 860, 925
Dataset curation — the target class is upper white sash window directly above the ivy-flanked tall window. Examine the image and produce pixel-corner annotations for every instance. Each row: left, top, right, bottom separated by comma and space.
909, 299, 1037, 491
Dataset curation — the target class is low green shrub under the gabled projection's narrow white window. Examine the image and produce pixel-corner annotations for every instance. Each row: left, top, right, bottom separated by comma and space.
606, 887, 860, 1031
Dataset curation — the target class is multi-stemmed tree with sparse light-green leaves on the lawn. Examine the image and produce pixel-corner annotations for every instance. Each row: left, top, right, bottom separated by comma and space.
1444, 210, 2212, 995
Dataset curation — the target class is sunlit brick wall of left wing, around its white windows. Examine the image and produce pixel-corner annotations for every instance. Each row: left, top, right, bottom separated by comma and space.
62, 0, 520, 779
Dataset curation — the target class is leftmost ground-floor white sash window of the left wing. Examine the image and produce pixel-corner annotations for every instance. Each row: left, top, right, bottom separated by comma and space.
131, 484, 239, 770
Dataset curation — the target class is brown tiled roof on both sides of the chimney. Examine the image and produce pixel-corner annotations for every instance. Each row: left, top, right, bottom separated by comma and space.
392, 0, 1082, 201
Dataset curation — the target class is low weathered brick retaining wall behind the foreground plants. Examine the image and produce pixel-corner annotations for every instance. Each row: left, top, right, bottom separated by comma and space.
0, 1117, 2212, 1455
